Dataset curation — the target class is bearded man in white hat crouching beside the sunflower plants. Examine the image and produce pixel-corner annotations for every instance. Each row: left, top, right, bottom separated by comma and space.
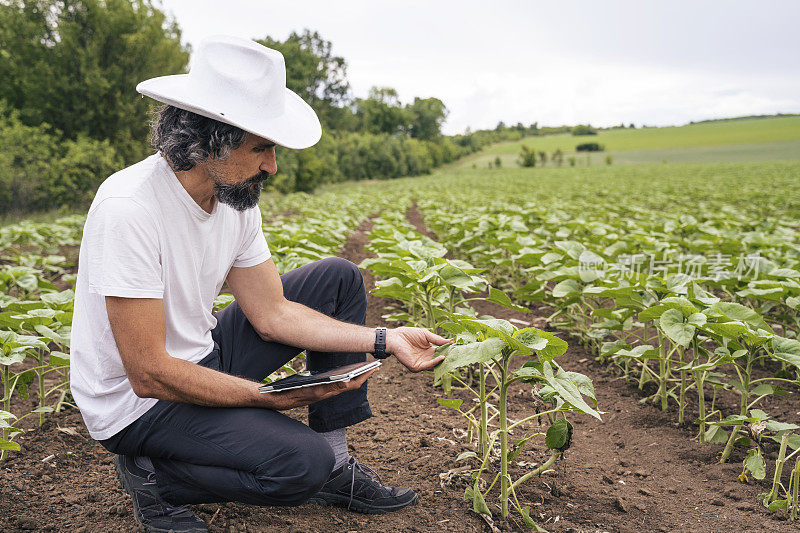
71, 37, 447, 532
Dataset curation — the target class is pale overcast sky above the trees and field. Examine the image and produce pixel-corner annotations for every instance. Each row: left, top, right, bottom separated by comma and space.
156, 0, 800, 134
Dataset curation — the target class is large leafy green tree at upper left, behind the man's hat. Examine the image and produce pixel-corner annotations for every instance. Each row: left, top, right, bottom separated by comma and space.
0, 0, 189, 162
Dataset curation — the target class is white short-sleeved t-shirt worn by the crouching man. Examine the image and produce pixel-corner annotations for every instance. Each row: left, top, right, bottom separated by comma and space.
70, 154, 270, 440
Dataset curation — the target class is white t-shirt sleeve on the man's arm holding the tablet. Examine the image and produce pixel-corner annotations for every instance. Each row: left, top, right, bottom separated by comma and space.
81, 198, 164, 298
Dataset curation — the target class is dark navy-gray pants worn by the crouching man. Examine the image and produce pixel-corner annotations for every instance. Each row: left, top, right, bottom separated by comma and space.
100, 258, 372, 505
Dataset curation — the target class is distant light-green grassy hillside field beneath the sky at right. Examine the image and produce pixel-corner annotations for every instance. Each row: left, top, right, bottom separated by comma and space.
457, 117, 800, 166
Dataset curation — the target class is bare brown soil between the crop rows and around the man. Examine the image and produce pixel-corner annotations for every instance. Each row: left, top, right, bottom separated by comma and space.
0, 212, 800, 532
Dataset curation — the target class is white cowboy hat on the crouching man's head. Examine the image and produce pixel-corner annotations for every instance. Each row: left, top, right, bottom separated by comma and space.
136, 35, 322, 149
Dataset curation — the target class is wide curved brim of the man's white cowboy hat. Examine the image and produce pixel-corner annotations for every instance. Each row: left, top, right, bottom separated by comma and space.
136, 74, 322, 150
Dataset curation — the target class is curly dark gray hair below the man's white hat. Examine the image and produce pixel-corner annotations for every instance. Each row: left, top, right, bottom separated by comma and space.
150, 105, 246, 170
